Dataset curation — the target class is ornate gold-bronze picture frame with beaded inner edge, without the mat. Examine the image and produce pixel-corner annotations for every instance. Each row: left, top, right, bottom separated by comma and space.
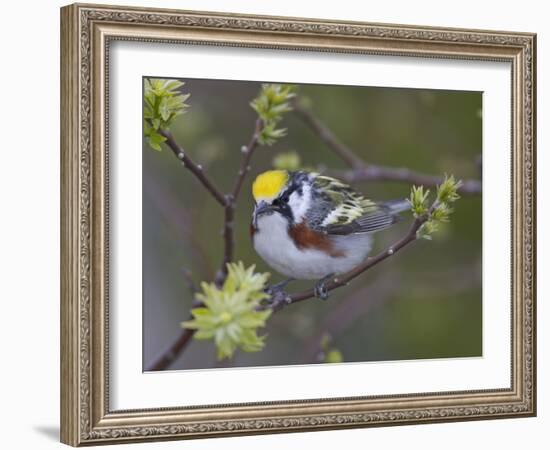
61, 4, 536, 446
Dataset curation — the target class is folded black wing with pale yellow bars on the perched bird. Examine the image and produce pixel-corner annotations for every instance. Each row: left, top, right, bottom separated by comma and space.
313, 175, 403, 235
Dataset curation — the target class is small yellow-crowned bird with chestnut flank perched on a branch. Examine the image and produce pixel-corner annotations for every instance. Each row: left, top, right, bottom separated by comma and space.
250, 170, 410, 299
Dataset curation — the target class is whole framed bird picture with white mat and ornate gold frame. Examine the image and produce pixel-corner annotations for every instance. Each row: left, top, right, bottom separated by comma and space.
61, 4, 536, 446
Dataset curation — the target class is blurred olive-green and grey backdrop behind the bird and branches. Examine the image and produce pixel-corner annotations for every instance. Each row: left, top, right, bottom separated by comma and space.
143, 79, 482, 369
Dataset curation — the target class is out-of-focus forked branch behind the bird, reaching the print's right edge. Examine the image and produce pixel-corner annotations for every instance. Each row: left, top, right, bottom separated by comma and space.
293, 101, 481, 195
